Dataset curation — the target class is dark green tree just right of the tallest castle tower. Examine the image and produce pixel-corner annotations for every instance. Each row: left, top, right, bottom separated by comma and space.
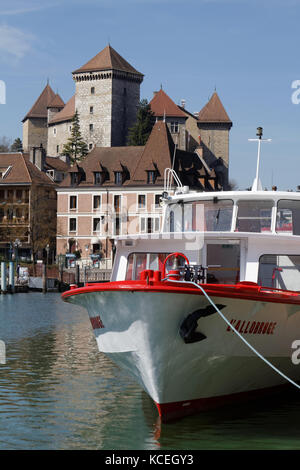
127, 99, 154, 146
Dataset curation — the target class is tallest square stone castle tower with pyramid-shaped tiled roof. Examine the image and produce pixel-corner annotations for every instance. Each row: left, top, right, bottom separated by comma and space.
73, 45, 143, 149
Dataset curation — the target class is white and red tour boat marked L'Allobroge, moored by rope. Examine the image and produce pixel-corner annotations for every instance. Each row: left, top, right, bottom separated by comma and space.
62, 137, 300, 421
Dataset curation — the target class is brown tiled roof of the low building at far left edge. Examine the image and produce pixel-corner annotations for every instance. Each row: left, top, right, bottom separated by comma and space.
0, 153, 53, 186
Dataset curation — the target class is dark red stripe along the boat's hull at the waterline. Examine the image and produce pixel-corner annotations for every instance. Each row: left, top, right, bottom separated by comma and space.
155, 384, 296, 423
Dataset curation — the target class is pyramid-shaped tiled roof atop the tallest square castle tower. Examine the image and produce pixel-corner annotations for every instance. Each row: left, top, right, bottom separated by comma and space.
73, 45, 143, 76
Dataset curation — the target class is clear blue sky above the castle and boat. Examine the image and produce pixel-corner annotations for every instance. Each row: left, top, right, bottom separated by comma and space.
0, 0, 300, 190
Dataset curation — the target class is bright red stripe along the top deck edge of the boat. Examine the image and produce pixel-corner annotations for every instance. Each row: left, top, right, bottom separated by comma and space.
62, 280, 300, 305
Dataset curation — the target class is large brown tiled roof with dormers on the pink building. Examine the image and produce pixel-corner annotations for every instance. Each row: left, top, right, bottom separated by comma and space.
60, 121, 214, 190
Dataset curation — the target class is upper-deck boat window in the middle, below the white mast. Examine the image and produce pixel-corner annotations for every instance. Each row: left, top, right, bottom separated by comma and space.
235, 200, 274, 232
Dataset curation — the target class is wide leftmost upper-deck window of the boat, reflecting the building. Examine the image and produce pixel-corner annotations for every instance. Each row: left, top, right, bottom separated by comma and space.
165, 198, 233, 232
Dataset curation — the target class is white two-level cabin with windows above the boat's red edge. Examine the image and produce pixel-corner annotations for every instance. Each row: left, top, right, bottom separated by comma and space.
112, 191, 300, 291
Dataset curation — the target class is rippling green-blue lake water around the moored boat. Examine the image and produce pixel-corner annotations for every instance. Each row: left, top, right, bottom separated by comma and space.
0, 292, 300, 451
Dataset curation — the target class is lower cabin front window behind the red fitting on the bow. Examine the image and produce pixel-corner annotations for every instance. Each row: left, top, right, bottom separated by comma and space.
125, 253, 169, 281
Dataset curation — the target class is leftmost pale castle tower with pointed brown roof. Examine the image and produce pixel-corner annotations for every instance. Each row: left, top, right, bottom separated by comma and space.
22, 84, 55, 152
